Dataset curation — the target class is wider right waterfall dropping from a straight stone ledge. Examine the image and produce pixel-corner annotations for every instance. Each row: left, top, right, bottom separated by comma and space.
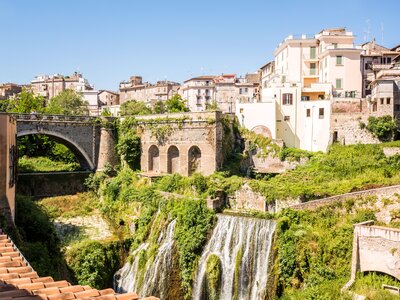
192, 215, 275, 300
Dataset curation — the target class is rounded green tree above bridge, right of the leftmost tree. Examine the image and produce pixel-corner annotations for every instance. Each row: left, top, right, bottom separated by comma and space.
47, 89, 89, 115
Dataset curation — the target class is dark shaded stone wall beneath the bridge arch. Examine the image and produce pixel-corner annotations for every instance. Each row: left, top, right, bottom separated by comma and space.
17, 172, 91, 198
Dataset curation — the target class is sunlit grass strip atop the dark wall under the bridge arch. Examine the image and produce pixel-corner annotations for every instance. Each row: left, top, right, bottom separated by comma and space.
18, 156, 80, 173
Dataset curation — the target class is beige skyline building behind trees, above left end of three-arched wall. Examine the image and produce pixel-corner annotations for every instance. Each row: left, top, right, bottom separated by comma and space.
119, 76, 180, 106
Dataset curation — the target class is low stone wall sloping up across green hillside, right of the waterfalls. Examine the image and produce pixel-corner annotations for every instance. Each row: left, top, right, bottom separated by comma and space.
288, 185, 400, 210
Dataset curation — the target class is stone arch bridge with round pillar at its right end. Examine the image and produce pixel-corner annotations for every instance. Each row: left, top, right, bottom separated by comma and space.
14, 114, 116, 171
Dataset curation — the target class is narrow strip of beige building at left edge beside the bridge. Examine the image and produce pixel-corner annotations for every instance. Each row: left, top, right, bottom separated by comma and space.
0, 114, 17, 221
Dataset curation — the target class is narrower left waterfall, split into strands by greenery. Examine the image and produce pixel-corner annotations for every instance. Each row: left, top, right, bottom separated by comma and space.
114, 220, 176, 299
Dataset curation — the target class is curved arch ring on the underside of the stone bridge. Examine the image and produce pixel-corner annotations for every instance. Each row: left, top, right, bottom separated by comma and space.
17, 129, 96, 170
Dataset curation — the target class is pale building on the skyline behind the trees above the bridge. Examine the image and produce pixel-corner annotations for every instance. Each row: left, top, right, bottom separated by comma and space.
31, 72, 93, 99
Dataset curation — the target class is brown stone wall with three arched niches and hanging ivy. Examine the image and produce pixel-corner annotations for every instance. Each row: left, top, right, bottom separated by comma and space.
138, 112, 233, 176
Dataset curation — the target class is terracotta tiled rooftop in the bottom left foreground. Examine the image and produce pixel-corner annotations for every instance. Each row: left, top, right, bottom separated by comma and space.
0, 229, 158, 300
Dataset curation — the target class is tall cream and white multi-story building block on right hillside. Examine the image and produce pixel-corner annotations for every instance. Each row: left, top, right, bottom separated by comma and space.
236, 28, 384, 151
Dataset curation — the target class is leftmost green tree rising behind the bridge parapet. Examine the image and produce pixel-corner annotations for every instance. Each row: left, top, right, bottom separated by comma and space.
7, 89, 45, 114
